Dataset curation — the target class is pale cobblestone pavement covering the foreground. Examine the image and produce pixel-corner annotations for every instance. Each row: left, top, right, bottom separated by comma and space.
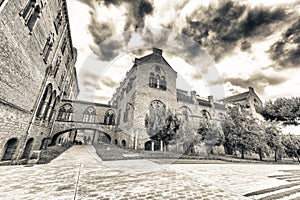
0, 146, 300, 199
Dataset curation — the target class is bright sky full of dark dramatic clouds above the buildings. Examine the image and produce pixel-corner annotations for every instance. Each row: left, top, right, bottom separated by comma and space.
68, 0, 300, 103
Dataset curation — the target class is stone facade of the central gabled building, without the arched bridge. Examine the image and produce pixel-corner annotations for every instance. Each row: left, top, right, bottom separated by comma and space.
109, 48, 225, 149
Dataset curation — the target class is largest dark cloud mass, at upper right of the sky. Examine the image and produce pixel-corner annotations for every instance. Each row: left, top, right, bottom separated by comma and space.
182, 1, 288, 62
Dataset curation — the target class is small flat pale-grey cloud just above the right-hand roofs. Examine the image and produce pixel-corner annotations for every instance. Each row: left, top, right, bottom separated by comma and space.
223, 72, 287, 94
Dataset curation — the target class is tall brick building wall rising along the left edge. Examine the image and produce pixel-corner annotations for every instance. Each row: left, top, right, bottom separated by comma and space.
0, 0, 79, 163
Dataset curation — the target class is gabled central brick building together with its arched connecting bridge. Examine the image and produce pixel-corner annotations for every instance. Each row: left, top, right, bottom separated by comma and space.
52, 48, 225, 154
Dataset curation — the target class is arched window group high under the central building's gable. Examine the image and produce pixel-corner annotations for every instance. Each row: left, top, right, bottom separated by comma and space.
149, 65, 167, 90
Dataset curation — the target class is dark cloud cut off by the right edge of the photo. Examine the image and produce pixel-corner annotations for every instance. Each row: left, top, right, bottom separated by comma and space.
269, 18, 300, 69
